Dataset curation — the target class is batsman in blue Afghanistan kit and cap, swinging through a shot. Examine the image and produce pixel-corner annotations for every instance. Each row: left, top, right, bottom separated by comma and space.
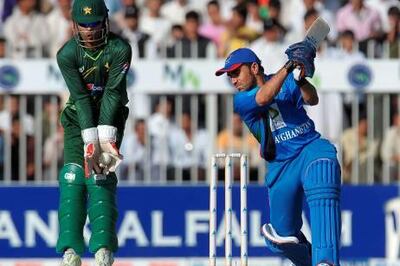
216, 46, 341, 266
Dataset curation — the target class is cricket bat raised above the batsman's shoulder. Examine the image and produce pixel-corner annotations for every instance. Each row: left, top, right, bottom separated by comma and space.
293, 17, 331, 80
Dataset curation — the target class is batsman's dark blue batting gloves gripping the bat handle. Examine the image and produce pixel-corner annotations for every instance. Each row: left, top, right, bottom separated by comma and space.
285, 41, 316, 78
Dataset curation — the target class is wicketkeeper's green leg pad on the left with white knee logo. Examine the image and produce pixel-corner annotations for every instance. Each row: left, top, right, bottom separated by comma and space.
56, 164, 86, 254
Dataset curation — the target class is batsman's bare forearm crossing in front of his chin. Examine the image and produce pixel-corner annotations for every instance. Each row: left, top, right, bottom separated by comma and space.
256, 60, 297, 106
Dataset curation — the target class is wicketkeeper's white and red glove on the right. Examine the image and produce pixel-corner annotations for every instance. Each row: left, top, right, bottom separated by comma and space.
97, 125, 123, 175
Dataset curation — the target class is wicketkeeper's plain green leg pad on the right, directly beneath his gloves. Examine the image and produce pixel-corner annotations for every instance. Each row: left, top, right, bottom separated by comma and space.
88, 183, 118, 253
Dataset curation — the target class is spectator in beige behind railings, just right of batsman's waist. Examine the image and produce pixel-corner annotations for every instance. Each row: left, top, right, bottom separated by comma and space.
341, 115, 378, 183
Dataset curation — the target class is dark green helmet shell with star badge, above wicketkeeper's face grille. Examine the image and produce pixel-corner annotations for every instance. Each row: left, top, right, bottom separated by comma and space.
72, 0, 108, 23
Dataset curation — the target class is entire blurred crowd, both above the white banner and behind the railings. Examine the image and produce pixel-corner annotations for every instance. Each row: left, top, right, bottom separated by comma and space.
0, 0, 400, 183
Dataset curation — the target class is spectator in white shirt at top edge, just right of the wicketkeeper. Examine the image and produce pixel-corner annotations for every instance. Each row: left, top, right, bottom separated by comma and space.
139, 0, 171, 45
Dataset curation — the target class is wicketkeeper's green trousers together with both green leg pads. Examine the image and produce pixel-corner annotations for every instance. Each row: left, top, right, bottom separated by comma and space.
56, 107, 128, 254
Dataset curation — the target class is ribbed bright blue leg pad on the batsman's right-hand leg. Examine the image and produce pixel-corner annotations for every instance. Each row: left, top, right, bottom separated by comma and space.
303, 159, 341, 265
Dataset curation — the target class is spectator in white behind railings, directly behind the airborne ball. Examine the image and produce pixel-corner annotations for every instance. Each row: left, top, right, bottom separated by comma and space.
170, 113, 212, 180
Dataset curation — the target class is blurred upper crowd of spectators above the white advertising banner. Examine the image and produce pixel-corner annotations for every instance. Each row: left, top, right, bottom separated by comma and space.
0, 0, 400, 59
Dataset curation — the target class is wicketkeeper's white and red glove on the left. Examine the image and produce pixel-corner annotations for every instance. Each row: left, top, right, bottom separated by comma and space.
81, 127, 101, 178
